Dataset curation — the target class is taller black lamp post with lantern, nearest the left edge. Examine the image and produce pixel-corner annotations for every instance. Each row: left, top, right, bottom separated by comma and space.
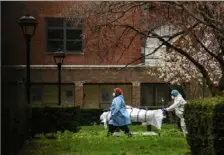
19, 14, 37, 104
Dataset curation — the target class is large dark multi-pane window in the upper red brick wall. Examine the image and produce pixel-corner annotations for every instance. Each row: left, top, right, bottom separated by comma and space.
46, 18, 83, 53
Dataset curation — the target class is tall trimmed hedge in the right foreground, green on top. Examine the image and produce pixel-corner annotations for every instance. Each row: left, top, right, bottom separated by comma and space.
184, 97, 224, 155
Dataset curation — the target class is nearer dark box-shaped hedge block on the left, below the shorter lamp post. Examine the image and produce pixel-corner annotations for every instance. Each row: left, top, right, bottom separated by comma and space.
30, 107, 80, 136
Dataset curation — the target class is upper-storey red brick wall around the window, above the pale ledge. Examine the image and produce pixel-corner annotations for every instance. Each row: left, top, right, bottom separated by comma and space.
1, 1, 140, 65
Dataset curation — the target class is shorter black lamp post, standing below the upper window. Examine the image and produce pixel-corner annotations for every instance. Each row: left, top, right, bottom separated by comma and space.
54, 51, 65, 105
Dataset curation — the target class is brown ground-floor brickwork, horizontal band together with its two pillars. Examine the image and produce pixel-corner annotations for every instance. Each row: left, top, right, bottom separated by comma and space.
4, 68, 163, 106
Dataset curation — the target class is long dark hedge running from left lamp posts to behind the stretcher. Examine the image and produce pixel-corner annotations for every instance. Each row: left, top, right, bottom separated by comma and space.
30, 106, 178, 136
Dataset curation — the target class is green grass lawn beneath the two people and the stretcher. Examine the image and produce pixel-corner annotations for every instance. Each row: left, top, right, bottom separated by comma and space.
19, 124, 190, 155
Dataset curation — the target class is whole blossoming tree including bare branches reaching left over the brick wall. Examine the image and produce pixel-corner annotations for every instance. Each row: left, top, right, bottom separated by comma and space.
63, 1, 224, 95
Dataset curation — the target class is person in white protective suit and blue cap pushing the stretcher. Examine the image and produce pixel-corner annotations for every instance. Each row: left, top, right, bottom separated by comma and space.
162, 90, 188, 136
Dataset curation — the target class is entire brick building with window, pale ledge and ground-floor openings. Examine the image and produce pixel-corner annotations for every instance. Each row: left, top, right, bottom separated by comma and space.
1, 1, 170, 108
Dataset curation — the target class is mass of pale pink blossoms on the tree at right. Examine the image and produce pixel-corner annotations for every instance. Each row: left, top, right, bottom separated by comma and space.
158, 22, 222, 93
